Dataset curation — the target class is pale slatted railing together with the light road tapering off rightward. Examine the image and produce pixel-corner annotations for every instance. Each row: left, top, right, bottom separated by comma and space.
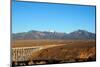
12, 44, 65, 61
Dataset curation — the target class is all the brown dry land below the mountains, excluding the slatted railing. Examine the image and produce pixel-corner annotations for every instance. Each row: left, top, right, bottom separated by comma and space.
12, 40, 96, 65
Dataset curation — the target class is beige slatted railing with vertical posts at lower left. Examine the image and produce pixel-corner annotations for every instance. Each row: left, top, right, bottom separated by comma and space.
12, 47, 38, 61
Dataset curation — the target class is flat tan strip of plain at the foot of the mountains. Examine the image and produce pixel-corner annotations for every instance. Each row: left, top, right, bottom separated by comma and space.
11, 40, 95, 48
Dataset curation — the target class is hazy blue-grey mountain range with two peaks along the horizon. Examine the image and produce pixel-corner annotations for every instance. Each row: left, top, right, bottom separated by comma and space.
12, 30, 96, 40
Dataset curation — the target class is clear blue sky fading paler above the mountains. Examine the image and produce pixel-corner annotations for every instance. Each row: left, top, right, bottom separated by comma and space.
12, 1, 95, 33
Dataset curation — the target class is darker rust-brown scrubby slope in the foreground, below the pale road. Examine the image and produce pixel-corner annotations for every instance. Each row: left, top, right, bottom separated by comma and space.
28, 41, 96, 60
